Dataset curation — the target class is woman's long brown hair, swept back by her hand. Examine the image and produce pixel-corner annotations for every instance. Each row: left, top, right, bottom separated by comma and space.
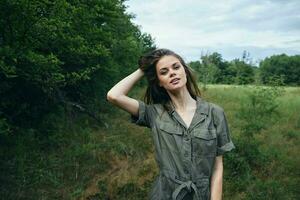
138, 49, 201, 108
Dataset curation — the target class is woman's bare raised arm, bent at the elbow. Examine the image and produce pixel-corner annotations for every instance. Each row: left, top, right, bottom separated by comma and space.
107, 69, 144, 116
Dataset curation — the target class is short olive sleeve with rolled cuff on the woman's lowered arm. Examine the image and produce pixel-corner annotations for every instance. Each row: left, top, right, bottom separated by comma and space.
213, 106, 235, 156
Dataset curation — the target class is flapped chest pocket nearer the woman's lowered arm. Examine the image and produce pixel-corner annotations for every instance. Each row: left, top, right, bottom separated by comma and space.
193, 129, 217, 156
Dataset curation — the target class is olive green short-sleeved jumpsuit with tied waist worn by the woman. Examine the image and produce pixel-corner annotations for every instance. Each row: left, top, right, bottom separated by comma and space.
131, 97, 235, 200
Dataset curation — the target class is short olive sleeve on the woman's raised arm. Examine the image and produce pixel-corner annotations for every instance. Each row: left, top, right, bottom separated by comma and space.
131, 100, 153, 128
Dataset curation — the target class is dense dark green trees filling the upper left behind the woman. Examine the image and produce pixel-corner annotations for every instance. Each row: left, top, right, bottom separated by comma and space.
0, 0, 154, 133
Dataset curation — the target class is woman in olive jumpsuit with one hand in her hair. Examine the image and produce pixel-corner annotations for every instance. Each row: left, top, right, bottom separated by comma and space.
107, 49, 235, 200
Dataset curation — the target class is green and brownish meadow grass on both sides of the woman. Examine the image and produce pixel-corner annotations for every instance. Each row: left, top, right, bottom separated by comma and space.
80, 85, 300, 200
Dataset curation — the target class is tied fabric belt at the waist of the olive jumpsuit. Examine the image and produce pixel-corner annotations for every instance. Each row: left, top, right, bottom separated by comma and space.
161, 169, 209, 200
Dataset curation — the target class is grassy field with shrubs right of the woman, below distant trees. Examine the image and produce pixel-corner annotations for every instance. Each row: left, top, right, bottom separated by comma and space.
205, 85, 300, 199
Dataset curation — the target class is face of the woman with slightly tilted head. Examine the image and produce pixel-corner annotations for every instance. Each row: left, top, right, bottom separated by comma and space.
156, 55, 187, 91
